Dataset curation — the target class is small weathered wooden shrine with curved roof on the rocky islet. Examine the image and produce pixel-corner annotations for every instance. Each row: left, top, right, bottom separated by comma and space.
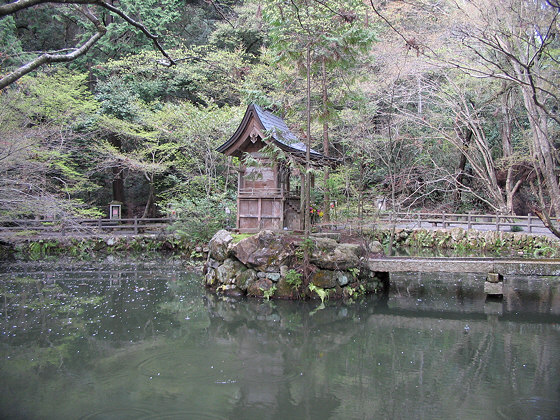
217, 104, 335, 232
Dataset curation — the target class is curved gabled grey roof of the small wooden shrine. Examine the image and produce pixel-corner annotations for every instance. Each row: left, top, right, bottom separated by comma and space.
216, 104, 335, 161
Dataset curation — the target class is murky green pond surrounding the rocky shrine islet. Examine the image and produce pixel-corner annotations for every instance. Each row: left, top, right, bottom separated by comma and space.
0, 260, 560, 420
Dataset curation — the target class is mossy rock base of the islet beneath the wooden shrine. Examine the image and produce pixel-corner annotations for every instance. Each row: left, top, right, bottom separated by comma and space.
204, 230, 384, 300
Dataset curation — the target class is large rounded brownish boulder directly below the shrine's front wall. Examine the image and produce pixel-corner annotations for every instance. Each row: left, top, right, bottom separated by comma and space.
230, 230, 295, 272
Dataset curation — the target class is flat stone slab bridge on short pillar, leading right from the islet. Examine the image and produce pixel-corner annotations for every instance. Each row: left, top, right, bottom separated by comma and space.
368, 257, 560, 295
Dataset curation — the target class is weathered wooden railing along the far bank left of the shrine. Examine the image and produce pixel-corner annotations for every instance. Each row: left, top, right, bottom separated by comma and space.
0, 217, 173, 236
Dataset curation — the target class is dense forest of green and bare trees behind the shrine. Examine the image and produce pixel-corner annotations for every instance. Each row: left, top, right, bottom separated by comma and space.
0, 0, 560, 243
